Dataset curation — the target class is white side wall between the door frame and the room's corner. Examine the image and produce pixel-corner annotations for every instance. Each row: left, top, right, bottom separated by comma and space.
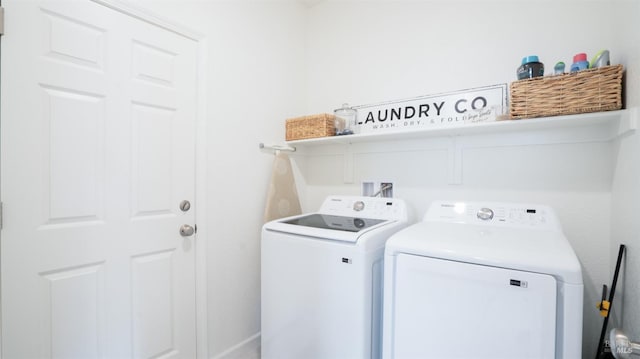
131, 0, 305, 358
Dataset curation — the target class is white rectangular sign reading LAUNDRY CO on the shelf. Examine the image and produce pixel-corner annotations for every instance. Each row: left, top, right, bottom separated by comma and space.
354, 84, 507, 133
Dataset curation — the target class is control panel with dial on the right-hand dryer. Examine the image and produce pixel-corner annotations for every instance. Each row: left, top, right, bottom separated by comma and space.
424, 201, 559, 229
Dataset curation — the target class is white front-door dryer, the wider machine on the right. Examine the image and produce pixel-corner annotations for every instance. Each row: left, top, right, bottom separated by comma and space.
383, 201, 583, 359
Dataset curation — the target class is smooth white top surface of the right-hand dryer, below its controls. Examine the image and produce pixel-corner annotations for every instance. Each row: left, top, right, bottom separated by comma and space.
385, 221, 582, 284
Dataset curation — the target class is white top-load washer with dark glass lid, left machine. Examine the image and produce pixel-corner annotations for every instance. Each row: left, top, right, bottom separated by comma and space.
261, 196, 408, 359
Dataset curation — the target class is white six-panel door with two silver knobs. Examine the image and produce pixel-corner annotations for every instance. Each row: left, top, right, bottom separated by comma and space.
0, 0, 197, 358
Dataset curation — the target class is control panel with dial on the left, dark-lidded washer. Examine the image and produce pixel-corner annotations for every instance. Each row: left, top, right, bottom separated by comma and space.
318, 196, 407, 220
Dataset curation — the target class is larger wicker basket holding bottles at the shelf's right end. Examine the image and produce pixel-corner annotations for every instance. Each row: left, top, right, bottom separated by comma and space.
510, 65, 622, 119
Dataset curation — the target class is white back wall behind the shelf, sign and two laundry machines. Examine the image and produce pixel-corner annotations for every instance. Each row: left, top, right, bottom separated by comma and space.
297, 0, 628, 357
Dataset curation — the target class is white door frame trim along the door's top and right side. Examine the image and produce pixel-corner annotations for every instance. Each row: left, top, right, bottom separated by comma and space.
0, 0, 209, 358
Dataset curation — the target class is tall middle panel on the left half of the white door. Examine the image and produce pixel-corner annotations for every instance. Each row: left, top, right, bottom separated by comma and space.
42, 87, 105, 224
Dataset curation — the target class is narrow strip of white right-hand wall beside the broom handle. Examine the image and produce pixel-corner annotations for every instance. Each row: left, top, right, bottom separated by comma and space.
609, 0, 640, 348
